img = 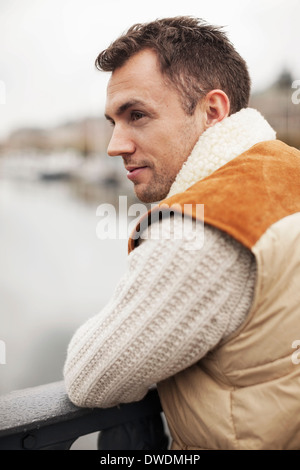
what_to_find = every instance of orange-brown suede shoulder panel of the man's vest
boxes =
[128,140,300,252]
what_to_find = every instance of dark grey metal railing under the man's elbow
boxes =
[0,382,169,450]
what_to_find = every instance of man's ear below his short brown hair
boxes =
[203,90,230,129]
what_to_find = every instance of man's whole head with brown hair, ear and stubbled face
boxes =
[96,17,250,202]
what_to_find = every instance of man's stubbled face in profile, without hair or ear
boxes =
[105,49,205,202]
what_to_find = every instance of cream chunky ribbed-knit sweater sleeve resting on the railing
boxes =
[64,218,256,408]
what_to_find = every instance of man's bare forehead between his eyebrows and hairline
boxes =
[106,49,168,114]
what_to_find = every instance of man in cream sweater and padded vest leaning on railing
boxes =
[64,17,300,449]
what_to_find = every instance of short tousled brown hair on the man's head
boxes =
[95,16,250,115]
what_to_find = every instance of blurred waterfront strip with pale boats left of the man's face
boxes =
[0,117,136,205]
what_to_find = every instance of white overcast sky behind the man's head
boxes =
[0,0,300,138]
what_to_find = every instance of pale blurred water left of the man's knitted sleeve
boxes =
[0,179,127,394]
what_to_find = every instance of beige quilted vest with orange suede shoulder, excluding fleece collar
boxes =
[129,141,300,449]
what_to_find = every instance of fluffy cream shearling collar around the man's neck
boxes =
[167,108,276,197]
